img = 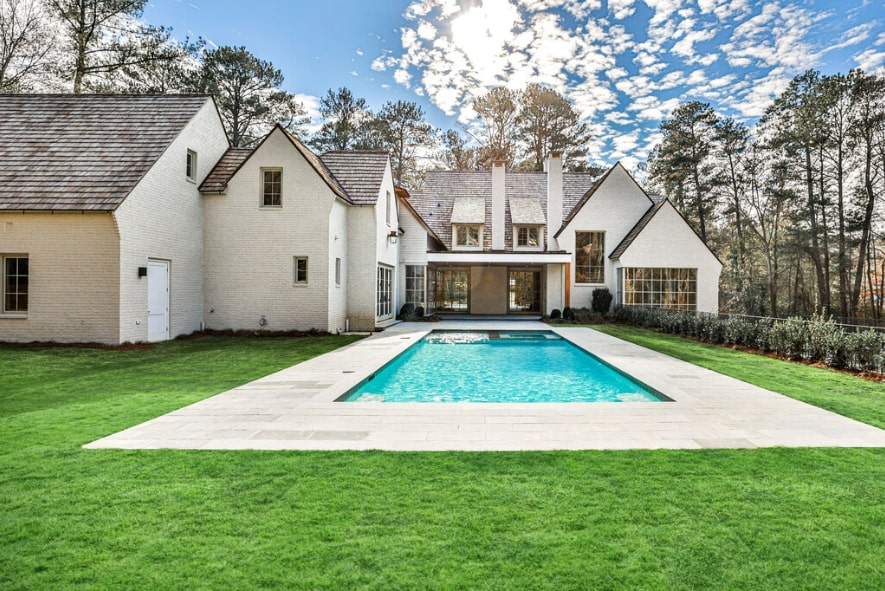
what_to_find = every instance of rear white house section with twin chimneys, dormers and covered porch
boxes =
[400,155,722,315]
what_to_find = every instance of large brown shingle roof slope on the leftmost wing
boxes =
[0,94,212,211]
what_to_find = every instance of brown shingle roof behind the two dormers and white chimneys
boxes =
[409,170,596,250]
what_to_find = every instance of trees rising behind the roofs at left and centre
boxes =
[0,0,590,186]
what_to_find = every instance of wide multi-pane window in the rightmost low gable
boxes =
[619,267,698,310]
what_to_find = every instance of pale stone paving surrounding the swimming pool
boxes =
[85,321,885,451]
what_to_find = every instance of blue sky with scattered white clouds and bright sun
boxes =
[144,0,885,166]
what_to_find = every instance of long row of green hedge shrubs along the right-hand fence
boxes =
[614,306,885,373]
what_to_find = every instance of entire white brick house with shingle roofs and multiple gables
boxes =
[0,95,721,344]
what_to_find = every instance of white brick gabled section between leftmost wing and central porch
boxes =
[201,126,399,332]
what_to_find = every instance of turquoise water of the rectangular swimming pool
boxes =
[343,331,661,402]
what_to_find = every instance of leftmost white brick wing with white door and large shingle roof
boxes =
[0,95,228,343]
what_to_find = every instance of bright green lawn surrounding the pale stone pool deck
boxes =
[0,327,885,591]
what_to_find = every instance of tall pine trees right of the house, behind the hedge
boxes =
[648,70,885,319]
